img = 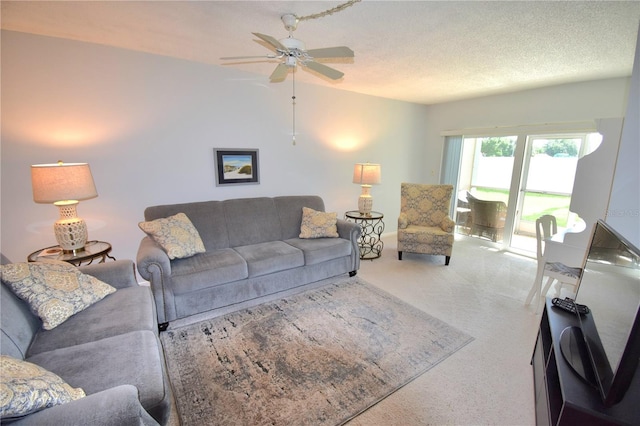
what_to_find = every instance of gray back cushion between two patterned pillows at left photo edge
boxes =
[0,283,41,359]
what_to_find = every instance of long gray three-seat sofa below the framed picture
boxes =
[136,196,361,326]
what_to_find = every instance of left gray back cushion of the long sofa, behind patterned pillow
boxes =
[144,201,230,251]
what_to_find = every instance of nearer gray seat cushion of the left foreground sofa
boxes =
[28,330,169,411]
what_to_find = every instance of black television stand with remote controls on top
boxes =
[531,299,640,426]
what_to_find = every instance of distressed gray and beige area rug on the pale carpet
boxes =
[161,277,473,426]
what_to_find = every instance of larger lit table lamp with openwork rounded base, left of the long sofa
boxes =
[31,161,98,253]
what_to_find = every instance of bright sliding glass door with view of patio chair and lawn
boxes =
[445,128,601,252]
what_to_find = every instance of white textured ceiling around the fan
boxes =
[1,0,640,104]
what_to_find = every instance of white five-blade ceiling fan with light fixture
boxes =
[220,14,354,83]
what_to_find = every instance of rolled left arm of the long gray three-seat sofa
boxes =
[136,237,177,324]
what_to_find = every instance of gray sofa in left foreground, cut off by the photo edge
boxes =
[0,260,173,426]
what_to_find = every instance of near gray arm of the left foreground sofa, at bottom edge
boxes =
[12,385,158,426]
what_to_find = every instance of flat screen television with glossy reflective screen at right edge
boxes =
[576,220,640,407]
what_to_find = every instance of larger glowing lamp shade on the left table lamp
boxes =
[31,163,98,203]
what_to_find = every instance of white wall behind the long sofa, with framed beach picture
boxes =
[0,31,430,261]
